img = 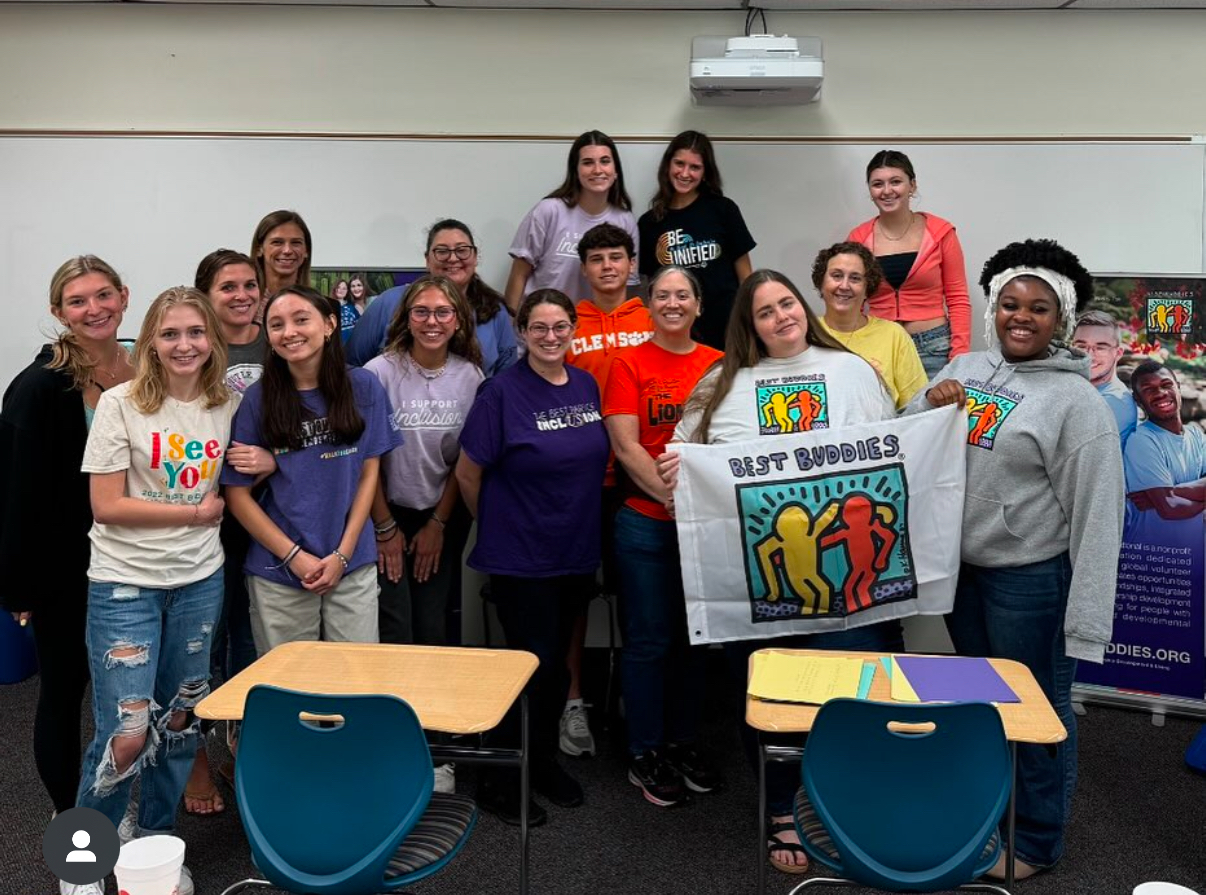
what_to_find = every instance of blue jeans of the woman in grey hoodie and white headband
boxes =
[947,554,1076,867]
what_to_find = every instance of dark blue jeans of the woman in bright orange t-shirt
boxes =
[615,507,706,755]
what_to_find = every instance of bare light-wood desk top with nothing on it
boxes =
[197,640,538,733]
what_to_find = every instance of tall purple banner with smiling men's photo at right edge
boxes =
[1073,275,1206,700]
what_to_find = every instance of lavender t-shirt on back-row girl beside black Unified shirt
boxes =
[508,199,640,302]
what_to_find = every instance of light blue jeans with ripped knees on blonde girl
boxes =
[76,569,222,835]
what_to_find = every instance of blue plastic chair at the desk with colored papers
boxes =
[792,700,1013,893]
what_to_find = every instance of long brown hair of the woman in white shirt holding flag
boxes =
[685,269,854,443]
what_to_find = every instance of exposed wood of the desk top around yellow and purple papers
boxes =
[745,649,1067,743]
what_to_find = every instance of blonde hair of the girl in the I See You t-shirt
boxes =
[130,286,230,414]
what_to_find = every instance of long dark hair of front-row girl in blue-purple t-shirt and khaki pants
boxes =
[259,286,364,451]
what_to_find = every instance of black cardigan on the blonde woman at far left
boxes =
[0,345,92,613]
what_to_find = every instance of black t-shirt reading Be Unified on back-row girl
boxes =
[637,193,757,351]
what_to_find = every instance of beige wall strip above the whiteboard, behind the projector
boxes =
[0,4,1206,138]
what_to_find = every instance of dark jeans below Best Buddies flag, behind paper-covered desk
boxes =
[725,619,905,818]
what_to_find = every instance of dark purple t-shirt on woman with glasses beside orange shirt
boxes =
[461,359,610,578]
